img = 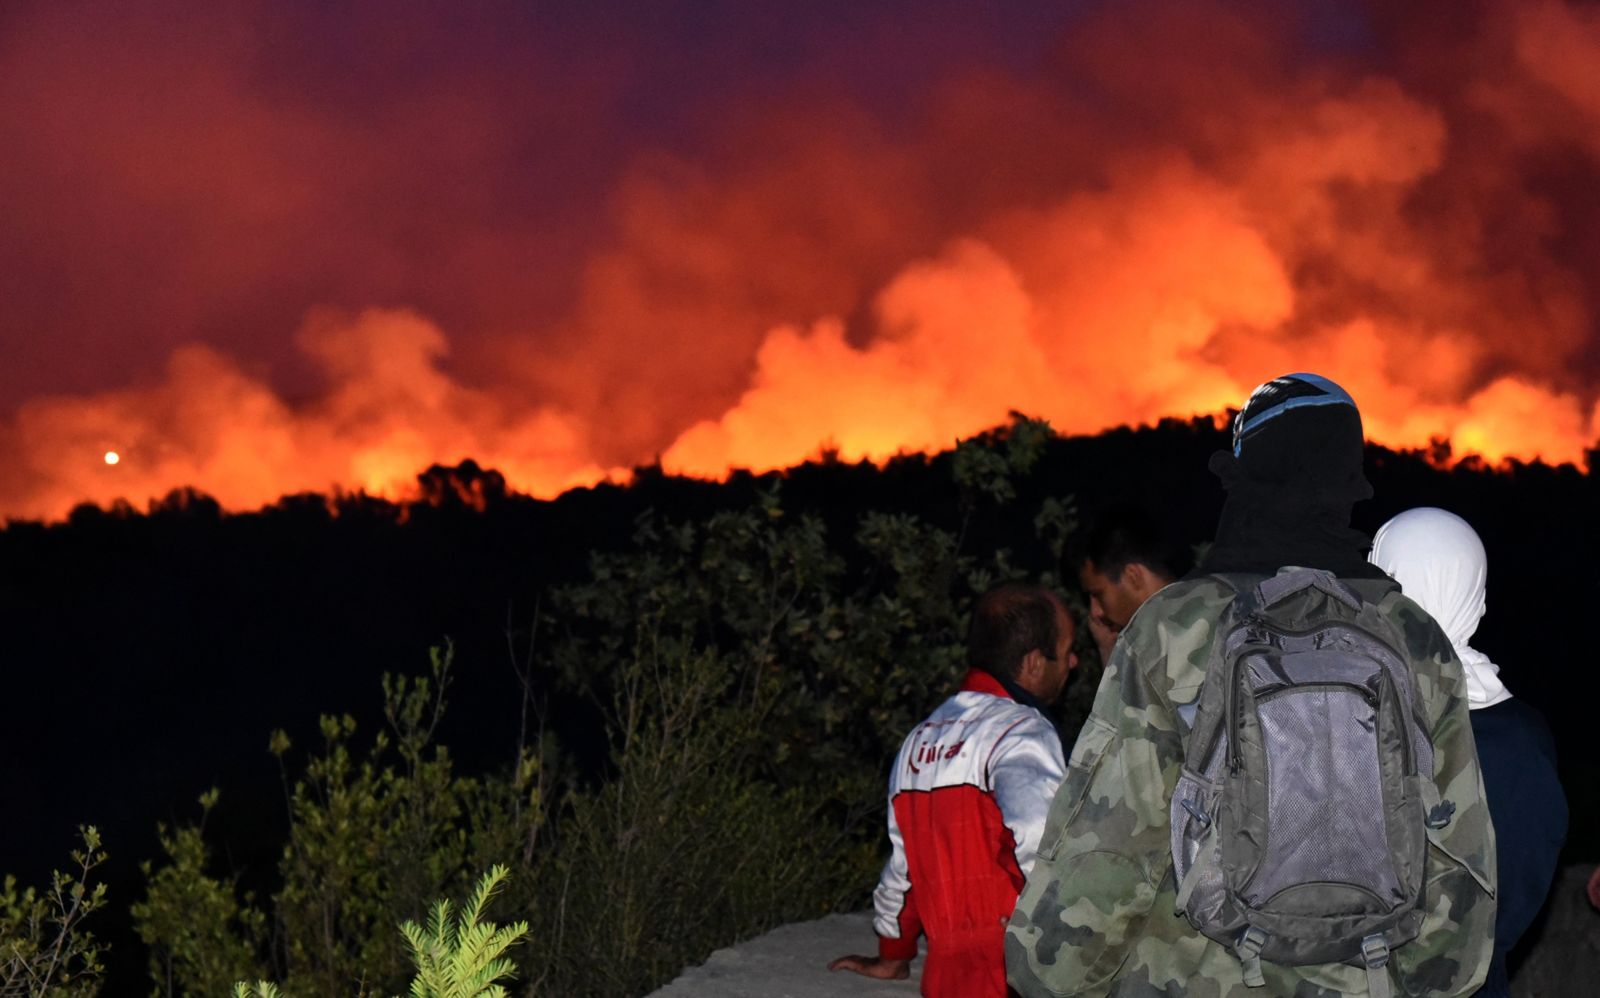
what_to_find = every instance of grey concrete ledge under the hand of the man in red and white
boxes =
[650,912,922,998]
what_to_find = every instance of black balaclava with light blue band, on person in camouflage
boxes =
[1195,374,1382,579]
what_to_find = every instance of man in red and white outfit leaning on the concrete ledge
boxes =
[829,584,1077,998]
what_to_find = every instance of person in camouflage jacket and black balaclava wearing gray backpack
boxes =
[1006,374,1494,998]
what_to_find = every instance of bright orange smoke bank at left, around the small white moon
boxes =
[3,310,606,518]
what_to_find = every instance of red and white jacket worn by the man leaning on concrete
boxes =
[872,669,1066,998]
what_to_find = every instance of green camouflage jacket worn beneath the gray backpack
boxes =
[1006,579,1494,998]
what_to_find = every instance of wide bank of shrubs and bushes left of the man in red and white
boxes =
[124,422,1072,995]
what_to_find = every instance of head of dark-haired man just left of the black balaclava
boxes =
[1078,505,1182,662]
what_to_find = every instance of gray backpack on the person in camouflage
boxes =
[1171,569,1453,998]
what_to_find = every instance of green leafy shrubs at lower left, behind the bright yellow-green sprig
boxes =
[133,648,526,995]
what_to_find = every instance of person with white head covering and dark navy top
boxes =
[1371,507,1566,998]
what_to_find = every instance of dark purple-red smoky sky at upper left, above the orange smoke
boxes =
[0,0,1066,409]
